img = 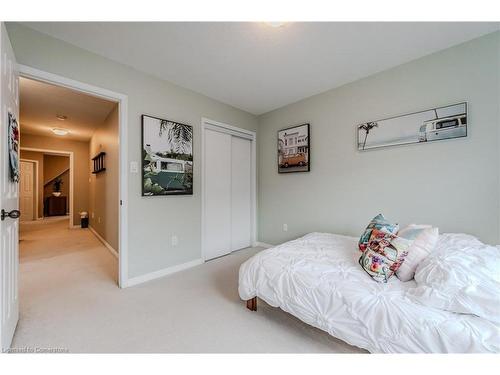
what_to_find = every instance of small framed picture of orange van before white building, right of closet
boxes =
[278,124,311,173]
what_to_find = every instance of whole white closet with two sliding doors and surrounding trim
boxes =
[202,119,256,260]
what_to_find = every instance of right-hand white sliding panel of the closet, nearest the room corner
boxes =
[231,136,252,251]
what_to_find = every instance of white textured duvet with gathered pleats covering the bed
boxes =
[239,233,500,353]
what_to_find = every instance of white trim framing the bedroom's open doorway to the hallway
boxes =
[18,64,128,288]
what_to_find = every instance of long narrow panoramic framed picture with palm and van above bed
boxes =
[357,102,467,151]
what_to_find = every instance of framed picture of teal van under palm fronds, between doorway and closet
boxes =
[142,115,193,196]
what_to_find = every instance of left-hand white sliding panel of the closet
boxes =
[204,129,232,259]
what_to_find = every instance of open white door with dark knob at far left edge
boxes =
[0,23,19,351]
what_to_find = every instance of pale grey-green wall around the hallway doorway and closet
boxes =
[7,23,258,277]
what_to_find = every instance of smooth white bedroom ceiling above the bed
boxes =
[20,22,499,115]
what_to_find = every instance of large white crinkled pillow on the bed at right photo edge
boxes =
[407,234,500,323]
